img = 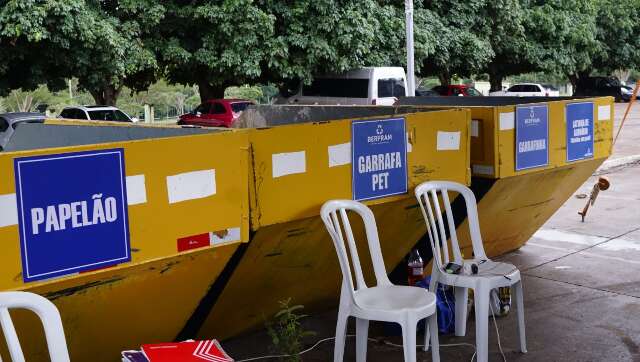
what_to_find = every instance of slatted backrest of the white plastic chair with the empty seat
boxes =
[320,200,391,293]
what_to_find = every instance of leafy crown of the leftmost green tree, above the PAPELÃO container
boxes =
[0,0,158,105]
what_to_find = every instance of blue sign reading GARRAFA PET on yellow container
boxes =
[351,118,407,200]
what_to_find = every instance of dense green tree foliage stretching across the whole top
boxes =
[0,0,640,104]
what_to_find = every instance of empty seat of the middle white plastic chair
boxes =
[355,285,436,312]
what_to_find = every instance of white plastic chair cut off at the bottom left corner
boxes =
[0,292,69,362]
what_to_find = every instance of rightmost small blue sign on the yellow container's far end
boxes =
[566,102,593,162]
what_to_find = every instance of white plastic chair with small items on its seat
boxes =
[415,181,527,362]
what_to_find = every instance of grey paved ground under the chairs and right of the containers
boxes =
[224,104,640,362]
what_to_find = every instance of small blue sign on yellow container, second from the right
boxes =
[516,105,549,171]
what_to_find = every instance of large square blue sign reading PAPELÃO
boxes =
[14,148,131,282]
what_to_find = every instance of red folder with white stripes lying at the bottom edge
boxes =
[142,339,233,362]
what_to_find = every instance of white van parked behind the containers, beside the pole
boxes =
[276,67,407,105]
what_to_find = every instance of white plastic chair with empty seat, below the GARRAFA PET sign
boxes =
[320,200,440,362]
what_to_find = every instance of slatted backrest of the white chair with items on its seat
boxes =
[415,181,487,269]
